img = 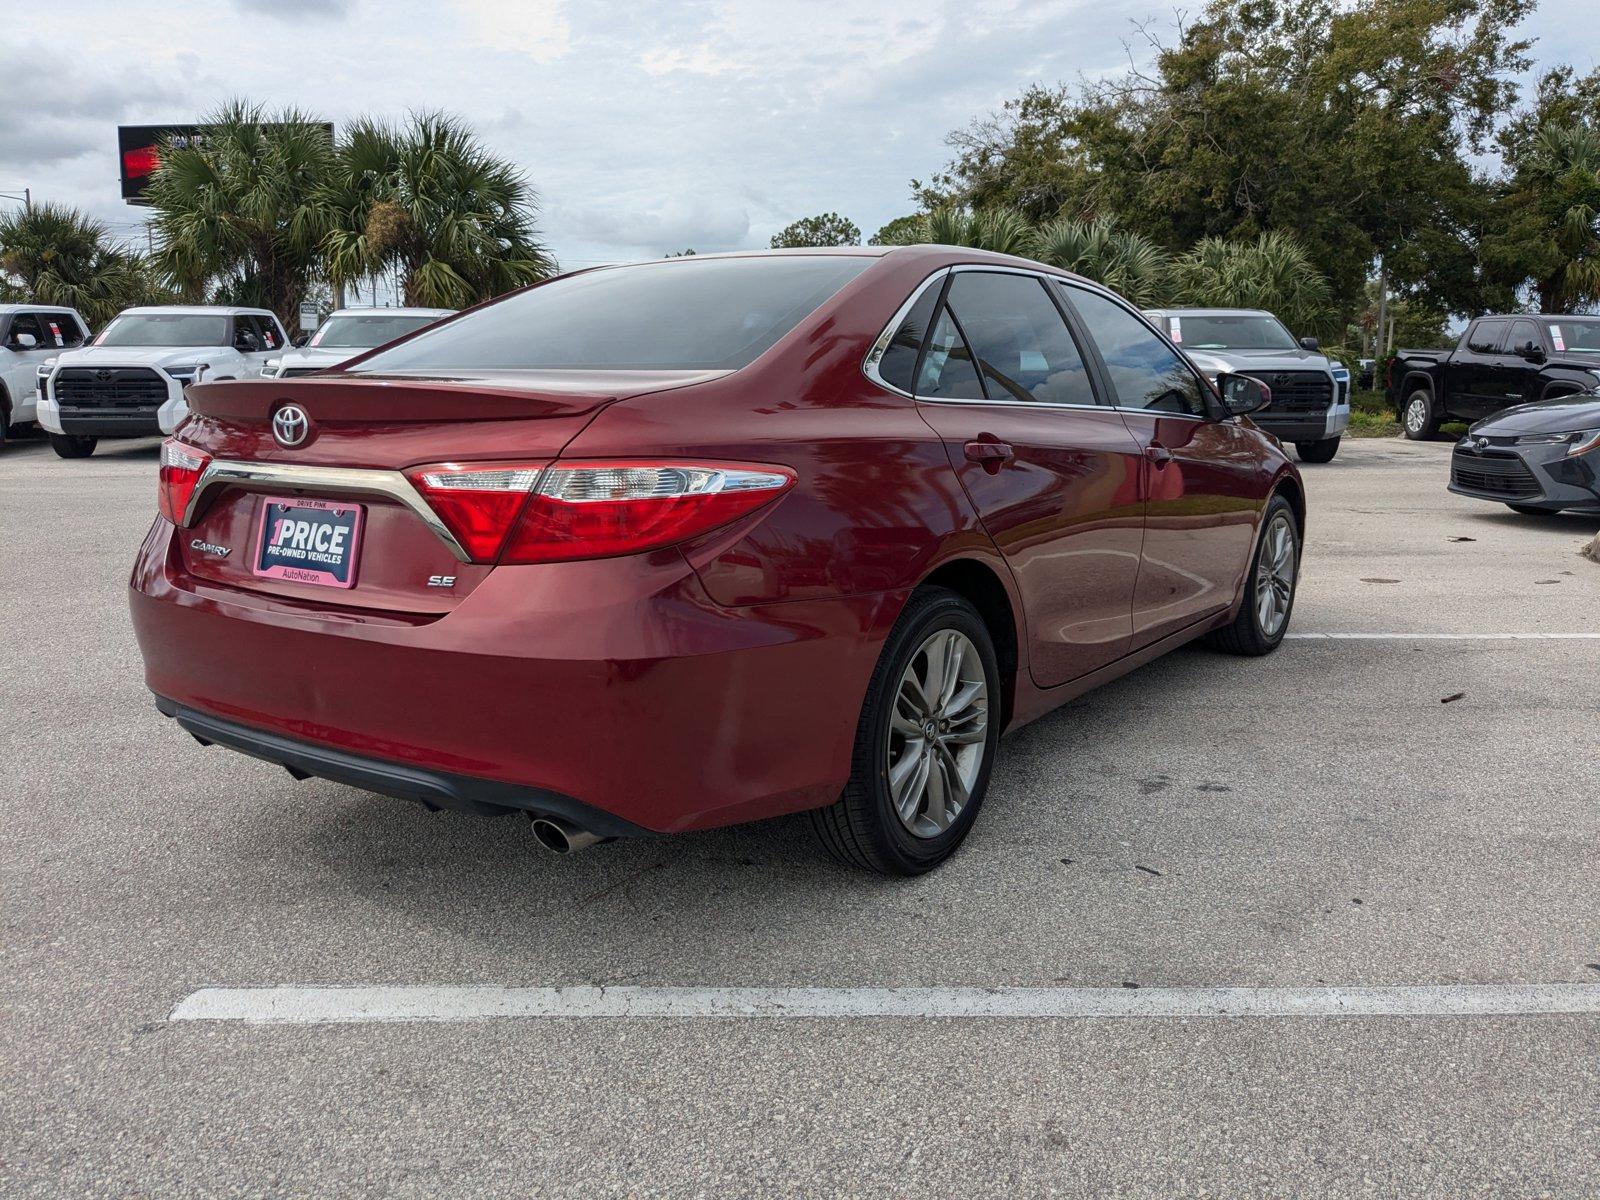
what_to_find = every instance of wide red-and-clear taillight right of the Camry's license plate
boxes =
[406,459,795,563]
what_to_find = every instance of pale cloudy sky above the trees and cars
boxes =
[0,0,1600,267]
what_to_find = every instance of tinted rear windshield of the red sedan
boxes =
[349,254,872,373]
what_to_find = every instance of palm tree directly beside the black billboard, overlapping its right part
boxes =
[146,101,333,325]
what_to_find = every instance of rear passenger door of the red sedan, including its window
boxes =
[915,269,1144,686]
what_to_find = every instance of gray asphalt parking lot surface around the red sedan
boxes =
[0,440,1600,1195]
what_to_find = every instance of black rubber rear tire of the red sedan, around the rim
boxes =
[811,587,1002,875]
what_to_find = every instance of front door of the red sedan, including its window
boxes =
[1058,283,1261,650]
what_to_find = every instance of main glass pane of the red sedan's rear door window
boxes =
[946,270,1094,405]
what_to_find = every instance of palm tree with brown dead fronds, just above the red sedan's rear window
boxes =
[318,114,555,307]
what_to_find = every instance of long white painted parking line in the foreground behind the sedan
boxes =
[170,984,1600,1026]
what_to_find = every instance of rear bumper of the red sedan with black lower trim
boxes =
[130,520,904,832]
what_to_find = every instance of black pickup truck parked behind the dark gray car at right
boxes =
[1386,315,1600,440]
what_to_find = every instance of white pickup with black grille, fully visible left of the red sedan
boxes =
[38,306,288,458]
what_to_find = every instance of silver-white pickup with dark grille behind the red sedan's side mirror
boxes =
[1144,309,1350,462]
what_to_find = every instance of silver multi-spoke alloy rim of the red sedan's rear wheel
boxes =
[885,629,989,838]
